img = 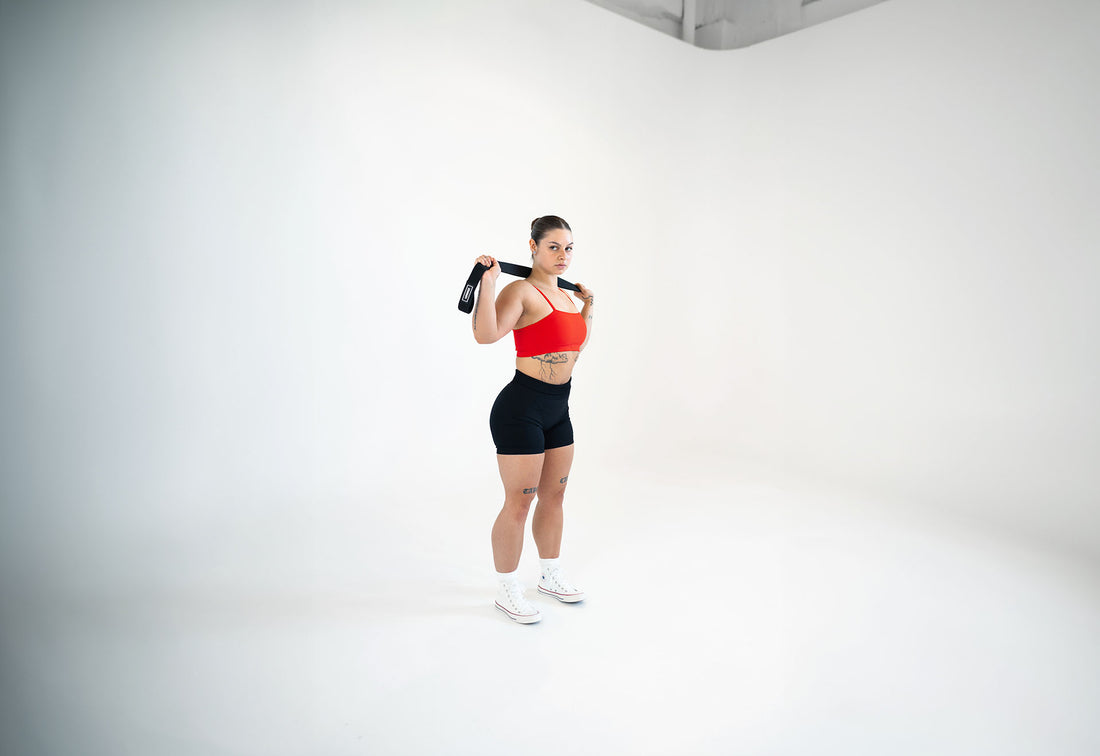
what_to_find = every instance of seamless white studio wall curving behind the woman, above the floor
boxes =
[3,1,1100,598]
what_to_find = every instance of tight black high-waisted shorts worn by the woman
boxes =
[488,370,573,454]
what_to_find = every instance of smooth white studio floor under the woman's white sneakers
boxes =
[0,476,1100,756]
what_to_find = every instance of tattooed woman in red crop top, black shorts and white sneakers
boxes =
[473,216,595,624]
